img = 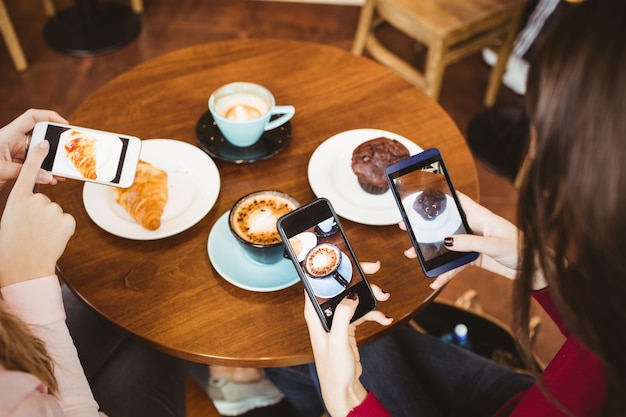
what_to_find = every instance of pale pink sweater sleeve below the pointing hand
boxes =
[1,275,99,417]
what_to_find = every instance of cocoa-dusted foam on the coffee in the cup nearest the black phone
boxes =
[231,194,296,245]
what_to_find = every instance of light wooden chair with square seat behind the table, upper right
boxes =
[352,0,528,107]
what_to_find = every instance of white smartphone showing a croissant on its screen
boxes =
[29,122,141,188]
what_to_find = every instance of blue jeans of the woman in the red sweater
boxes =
[266,326,533,417]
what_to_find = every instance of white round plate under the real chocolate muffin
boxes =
[308,129,423,226]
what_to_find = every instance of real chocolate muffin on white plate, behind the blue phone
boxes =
[352,137,410,194]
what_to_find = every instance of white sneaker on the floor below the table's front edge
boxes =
[207,376,285,416]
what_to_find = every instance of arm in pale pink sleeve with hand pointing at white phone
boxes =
[0,141,98,416]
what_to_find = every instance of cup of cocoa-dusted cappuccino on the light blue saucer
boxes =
[228,190,300,264]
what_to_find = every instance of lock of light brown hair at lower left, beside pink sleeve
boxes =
[0,300,58,395]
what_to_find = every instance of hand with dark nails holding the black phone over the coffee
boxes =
[304,262,393,416]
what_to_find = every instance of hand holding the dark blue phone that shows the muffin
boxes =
[401,193,519,289]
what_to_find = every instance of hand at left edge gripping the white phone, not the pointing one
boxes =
[0,109,68,189]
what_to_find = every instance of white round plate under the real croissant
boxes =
[83,139,220,240]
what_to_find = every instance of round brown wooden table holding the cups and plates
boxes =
[43,39,478,367]
